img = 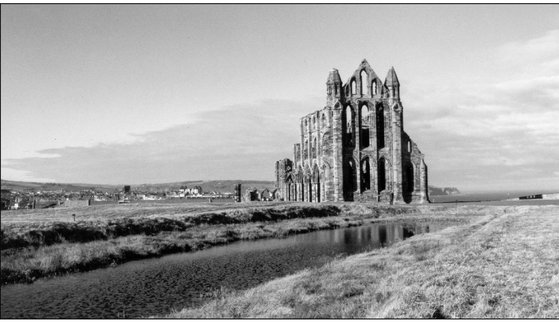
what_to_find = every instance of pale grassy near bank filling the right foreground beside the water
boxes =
[165,206,559,318]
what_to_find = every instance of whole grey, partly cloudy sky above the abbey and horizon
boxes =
[1,4,559,191]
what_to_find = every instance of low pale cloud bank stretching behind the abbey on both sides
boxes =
[2,30,559,190]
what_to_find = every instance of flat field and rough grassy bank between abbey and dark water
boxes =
[0,203,475,285]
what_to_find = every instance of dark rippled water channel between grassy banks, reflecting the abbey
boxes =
[1,223,450,318]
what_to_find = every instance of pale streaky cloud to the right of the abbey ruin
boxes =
[405,30,559,189]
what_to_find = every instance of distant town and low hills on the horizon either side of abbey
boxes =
[1,180,460,210]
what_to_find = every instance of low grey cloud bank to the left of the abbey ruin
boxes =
[2,100,313,183]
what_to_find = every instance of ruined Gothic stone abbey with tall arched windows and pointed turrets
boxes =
[276,60,429,204]
